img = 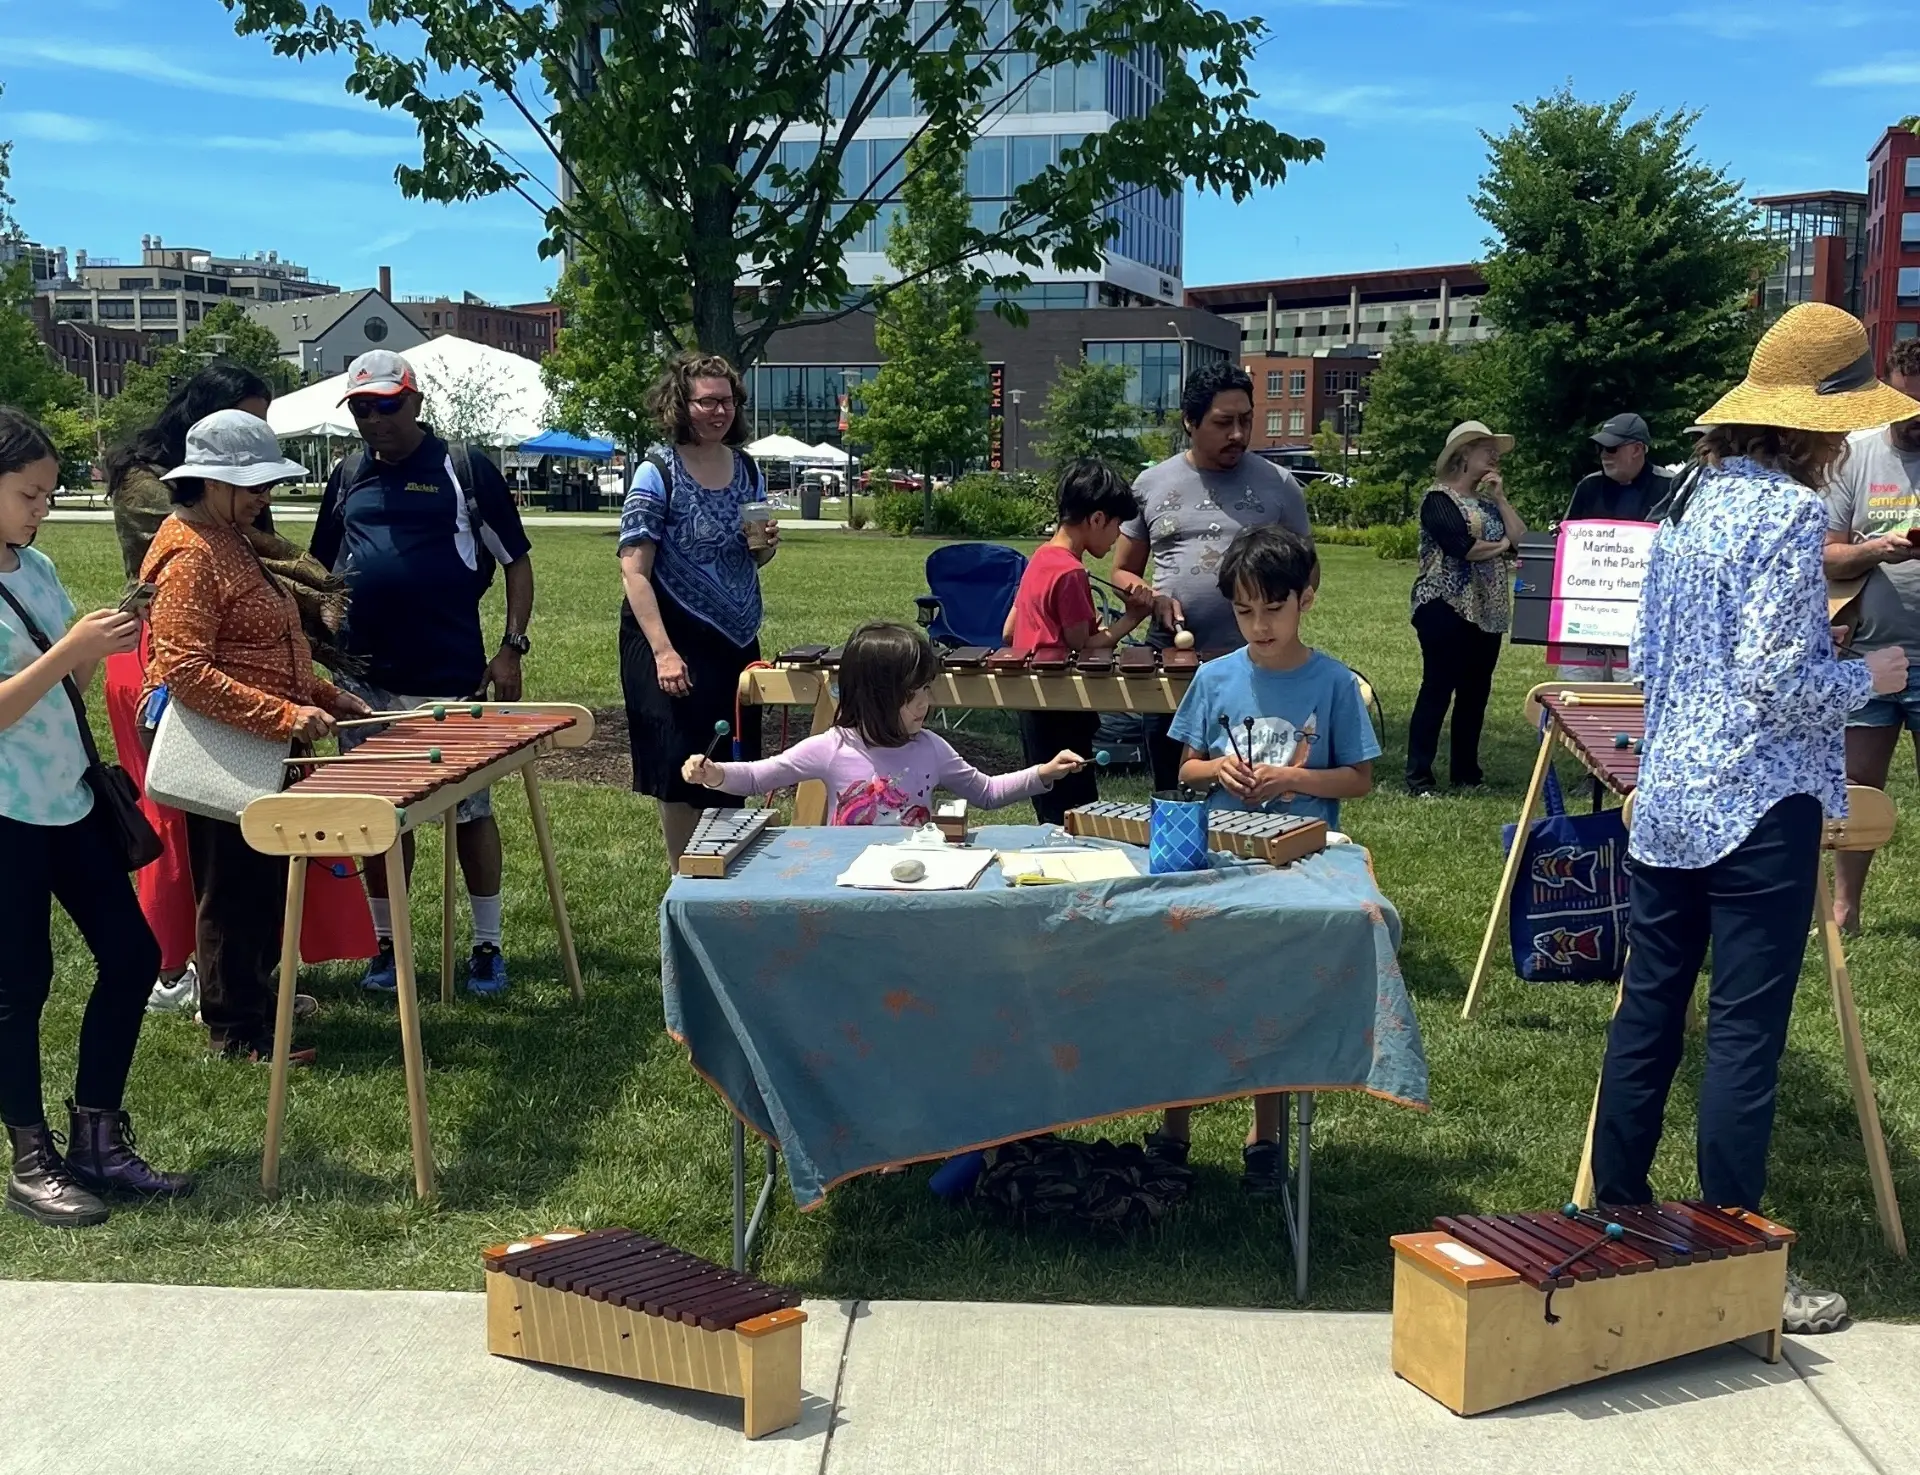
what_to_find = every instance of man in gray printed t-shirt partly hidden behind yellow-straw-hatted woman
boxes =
[1826,338,1920,931]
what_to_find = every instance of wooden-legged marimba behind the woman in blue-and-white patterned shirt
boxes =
[1461,682,1907,1258]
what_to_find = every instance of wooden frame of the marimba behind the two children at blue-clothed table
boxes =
[739,664,1198,824]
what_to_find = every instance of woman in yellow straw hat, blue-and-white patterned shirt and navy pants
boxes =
[1594,303,1920,1333]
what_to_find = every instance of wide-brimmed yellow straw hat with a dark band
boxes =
[1699,302,1920,432]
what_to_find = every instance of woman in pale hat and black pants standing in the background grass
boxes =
[1407,421,1526,795]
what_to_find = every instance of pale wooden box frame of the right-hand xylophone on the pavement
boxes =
[1392,1214,1793,1415]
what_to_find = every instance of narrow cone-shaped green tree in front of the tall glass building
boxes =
[847,136,987,505]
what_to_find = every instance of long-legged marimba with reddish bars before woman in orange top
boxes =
[240,701,593,1198]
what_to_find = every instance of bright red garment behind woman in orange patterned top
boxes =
[106,632,376,972]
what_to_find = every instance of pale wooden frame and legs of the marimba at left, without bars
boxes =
[240,701,593,1198]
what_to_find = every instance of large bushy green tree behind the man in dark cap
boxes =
[1475,90,1776,517]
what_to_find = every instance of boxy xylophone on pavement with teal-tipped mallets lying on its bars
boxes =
[1392,1202,1793,1414]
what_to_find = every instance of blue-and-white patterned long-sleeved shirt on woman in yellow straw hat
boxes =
[1630,457,1870,870]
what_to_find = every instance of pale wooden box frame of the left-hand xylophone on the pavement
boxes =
[482,1229,806,1439]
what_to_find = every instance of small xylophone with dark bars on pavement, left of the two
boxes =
[480,1229,806,1439]
